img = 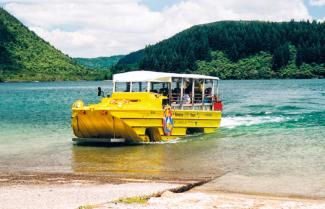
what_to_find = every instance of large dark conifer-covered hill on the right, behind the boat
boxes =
[114,21,325,79]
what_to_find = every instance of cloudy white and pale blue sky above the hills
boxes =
[0,0,325,57]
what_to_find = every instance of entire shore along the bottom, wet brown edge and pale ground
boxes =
[0,173,325,209]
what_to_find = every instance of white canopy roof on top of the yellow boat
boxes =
[113,70,219,82]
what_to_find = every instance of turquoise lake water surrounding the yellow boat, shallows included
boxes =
[0,80,325,197]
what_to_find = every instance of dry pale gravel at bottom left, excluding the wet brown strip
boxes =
[0,182,182,209]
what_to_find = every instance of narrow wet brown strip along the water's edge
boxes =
[0,171,325,201]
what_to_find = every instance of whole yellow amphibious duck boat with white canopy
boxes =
[72,71,222,143]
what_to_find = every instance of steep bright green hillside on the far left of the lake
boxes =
[0,8,104,81]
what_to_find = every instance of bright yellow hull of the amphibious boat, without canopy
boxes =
[72,92,221,143]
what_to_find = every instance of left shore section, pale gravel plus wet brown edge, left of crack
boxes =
[0,173,184,209]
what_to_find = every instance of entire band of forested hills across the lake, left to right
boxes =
[0,5,325,81]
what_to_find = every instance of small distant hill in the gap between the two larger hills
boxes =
[73,55,124,69]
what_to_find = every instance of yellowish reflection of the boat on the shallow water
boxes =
[72,136,224,179]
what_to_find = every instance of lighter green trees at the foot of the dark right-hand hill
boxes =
[195,45,325,79]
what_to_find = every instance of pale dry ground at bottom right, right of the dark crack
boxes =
[102,192,325,209]
